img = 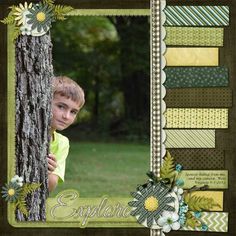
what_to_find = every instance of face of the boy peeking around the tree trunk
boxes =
[51,94,80,130]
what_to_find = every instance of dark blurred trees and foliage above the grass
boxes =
[51,16,150,143]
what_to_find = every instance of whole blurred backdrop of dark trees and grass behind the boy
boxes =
[51,16,150,197]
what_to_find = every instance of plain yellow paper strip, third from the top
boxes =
[164,47,219,66]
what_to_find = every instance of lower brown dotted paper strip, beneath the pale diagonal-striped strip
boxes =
[168,148,225,170]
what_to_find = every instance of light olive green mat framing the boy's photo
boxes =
[8,6,157,230]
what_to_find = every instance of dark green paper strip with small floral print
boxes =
[164,66,228,88]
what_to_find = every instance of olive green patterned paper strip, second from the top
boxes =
[165,27,224,47]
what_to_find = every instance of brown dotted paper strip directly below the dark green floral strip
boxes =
[164,88,232,108]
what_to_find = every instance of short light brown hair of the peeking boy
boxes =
[53,76,85,108]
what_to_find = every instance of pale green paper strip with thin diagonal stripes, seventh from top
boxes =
[164,129,215,148]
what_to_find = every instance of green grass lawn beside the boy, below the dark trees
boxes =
[50,142,150,197]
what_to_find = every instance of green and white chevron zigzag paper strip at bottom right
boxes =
[180,212,229,232]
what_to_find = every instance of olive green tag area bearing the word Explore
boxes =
[46,189,138,227]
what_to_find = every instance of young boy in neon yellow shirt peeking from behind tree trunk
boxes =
[48,76,85,192]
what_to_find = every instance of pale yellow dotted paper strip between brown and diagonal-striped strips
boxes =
[165,108,228,129]
